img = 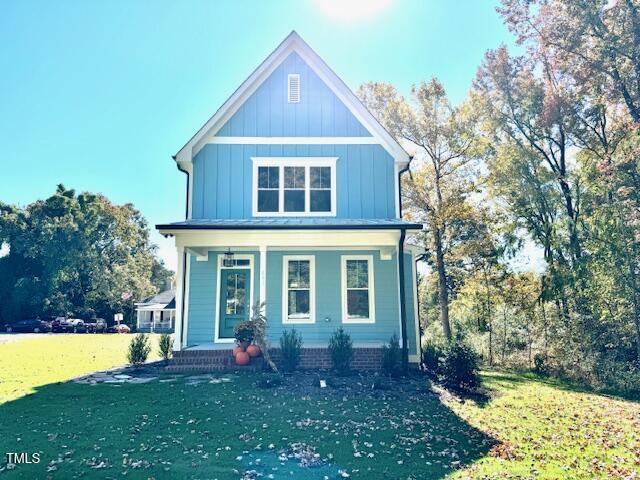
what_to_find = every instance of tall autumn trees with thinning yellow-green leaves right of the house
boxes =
[359,0,640,398]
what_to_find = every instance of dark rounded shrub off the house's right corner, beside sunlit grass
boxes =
[438,336,479,390]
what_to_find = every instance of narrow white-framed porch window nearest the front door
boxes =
[282,255,316,324]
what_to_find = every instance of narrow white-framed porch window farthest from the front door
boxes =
[341,255,376,323]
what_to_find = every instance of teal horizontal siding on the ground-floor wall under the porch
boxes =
[187,250,416,354]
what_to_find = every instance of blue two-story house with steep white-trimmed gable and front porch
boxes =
[157,32,422,368]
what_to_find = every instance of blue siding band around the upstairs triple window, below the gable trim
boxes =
[192,144,396,219]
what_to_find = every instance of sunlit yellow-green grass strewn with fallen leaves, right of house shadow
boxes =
[448,372,640,479]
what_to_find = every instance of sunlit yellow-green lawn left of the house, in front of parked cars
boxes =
[0,334,158,402]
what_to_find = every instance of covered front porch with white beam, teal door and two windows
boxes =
[161,224,421,369]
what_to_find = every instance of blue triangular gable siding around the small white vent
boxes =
[216,52,371,137]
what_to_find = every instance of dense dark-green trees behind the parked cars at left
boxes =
[0,185,172,323]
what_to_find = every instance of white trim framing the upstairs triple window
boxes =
[251,157,338,217]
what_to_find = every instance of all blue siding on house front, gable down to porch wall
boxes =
[176,34,418,355]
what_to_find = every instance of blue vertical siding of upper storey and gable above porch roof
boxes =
[191,48,397,219]
